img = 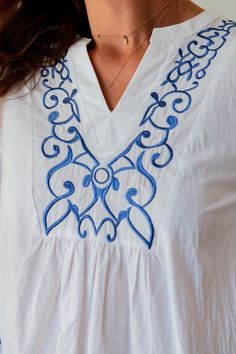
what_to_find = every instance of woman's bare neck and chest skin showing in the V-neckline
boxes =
[85,0,204,111]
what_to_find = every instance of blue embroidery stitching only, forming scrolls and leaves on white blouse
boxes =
[41,20,236,249]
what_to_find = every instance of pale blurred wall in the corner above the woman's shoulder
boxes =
[193,0,236,20]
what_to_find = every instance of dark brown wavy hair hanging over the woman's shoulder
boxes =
[0,0,91,97]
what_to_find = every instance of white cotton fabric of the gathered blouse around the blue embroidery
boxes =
[0,9,236,354]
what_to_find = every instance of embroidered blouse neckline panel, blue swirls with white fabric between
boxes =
[41,20,236,249]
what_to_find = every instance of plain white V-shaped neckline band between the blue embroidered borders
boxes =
[66,10,218,162]
